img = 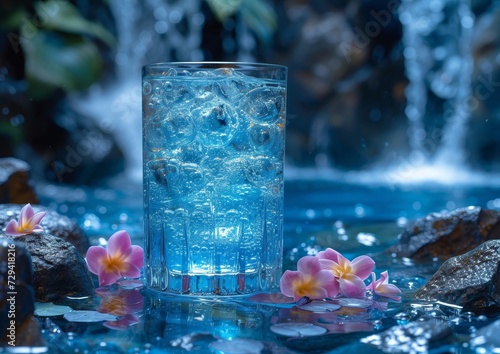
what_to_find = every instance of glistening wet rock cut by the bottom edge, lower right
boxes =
[361,319,453,353]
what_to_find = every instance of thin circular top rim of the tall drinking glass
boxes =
[142,61,288,70]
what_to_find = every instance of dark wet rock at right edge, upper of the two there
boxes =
[389,207,500,260]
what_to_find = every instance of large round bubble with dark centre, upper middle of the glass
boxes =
[193,101,238,146]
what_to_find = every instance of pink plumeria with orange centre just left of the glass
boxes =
[86,231,144,286]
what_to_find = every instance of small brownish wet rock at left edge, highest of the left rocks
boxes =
[0,157,38,204]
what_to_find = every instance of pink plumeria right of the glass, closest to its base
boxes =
[280,256,339,301]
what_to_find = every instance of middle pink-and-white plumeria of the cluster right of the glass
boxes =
[316,248,375,298]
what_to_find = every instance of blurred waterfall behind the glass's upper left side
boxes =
[70,0,204,182]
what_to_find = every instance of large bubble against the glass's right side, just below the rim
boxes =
[241,87,285,123]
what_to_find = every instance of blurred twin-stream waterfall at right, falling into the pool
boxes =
[399,0,474,172]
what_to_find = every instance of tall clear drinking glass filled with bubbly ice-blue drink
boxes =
[142,62,287,296]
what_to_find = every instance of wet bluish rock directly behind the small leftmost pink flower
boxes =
[0,204,90,254]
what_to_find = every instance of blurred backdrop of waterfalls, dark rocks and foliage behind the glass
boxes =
[0,0,500,185]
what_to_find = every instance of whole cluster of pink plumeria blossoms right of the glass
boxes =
[280,248,401,304]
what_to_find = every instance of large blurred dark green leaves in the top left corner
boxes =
[3,0,115,99]
